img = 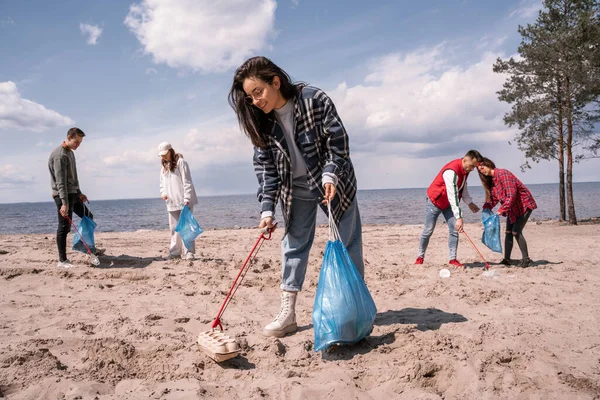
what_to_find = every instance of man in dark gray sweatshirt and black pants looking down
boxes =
[48,128,99,268]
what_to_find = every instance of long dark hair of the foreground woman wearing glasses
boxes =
[228,56,306,148]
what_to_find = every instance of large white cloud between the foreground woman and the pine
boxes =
[331,45,507,155]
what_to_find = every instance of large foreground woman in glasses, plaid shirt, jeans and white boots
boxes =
[229,57,364,337]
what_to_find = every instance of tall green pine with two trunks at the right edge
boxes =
[494,0,600,224]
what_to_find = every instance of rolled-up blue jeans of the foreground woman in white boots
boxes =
[281,191,365,292]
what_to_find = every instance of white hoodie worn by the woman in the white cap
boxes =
[160,157,198,211]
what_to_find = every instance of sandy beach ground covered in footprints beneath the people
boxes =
[0,221,600,400]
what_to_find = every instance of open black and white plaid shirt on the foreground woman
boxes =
[253,86,356,231]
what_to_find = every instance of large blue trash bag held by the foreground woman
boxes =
[312,240,377,351]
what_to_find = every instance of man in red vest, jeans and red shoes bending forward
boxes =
[415,150,483,267]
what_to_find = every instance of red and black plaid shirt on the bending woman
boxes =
[484,168,537,223]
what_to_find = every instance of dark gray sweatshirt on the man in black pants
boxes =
[48,144,81,205]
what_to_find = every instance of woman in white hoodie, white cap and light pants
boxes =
[158,142,198,260]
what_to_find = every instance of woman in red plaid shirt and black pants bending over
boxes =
[477,157,537,268]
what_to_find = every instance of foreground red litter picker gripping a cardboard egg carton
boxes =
[198,224,277,362]
